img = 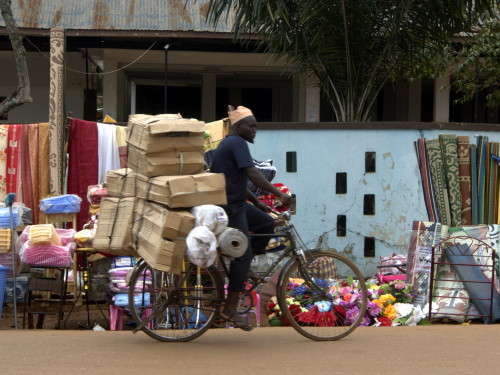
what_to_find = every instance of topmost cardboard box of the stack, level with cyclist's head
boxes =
[127,115,205,154]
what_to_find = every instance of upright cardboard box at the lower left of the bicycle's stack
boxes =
[92,198,137,256]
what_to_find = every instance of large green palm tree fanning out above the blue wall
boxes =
[208,0,495,122]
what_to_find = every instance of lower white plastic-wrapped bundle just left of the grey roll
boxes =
[186,225,217,268]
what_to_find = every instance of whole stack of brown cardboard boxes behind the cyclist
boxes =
[93,115,226,273]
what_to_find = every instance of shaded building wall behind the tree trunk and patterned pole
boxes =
[0,52,85,123]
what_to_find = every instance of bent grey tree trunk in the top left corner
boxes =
[0,0,32,116]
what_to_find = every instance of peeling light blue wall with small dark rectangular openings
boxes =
[250,129,500,276]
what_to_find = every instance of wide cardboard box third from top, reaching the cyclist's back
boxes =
[136,172,227,208]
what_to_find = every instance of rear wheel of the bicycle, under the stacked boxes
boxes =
[129,262,224,341]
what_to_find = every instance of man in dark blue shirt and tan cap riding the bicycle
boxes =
[210,106,292,331]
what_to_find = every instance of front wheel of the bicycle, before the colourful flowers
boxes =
[277,250,368,341]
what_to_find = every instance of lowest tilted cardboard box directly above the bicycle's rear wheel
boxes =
[137,220,186,274]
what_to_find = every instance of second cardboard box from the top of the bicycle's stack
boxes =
[127,146,205,177]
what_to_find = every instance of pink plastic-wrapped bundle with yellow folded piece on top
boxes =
[18,224,76,268]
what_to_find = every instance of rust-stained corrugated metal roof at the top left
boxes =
[0,0,232,32]
